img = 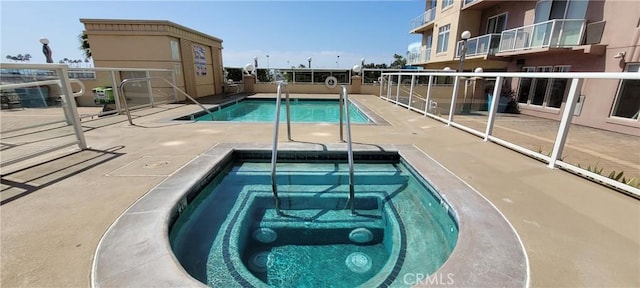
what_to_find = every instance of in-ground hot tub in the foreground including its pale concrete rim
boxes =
[91,142,529,287]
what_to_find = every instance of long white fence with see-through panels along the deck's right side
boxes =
[380,72,640,198]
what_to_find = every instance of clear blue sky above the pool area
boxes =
[0,0,425,68]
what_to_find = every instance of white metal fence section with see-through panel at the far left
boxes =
[0,63,87,166]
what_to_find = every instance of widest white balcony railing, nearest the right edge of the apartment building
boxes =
[498,19,586,52]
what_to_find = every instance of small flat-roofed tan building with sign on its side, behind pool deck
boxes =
[80,19,223,97]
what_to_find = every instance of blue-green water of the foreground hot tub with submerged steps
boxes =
[170,161,458,287]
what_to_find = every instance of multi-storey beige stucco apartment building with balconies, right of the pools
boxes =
[407,0,640,135]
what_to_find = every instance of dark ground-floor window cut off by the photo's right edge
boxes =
[611,63,640,120]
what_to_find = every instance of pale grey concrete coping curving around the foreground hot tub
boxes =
[91,142,530,287]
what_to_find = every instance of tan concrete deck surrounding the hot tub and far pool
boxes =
[0,95,640,287]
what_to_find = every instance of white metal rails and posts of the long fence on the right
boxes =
[380,72,640,198]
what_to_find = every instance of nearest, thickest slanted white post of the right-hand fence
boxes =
[547,78,583,168]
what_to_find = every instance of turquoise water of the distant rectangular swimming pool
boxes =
[195,99,371,123]
